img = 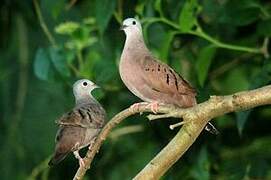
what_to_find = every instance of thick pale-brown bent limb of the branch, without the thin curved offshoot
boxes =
[134,85,271,180]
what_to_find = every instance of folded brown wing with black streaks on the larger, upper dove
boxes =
[140,55,196,96]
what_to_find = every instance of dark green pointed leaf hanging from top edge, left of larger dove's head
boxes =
[95,0,116,33]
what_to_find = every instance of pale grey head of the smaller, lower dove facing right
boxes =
[73,79,99,99]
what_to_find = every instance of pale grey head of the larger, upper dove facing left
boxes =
[121,18,142,36]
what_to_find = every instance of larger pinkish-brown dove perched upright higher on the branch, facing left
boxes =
[119,18,218,134]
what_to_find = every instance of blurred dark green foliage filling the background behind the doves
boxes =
[0,0,271,180]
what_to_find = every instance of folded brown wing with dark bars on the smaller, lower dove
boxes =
[57,103,105,129]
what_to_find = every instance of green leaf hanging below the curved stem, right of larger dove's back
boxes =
[196,45,216,86]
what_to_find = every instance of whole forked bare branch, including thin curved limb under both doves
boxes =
[74,85,271,180]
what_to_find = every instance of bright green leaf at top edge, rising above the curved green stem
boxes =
[179,0,199,32]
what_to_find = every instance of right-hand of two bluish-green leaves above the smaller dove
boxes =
[49,47,70,77]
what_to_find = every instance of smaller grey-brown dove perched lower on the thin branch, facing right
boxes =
[48,79,106,166]
